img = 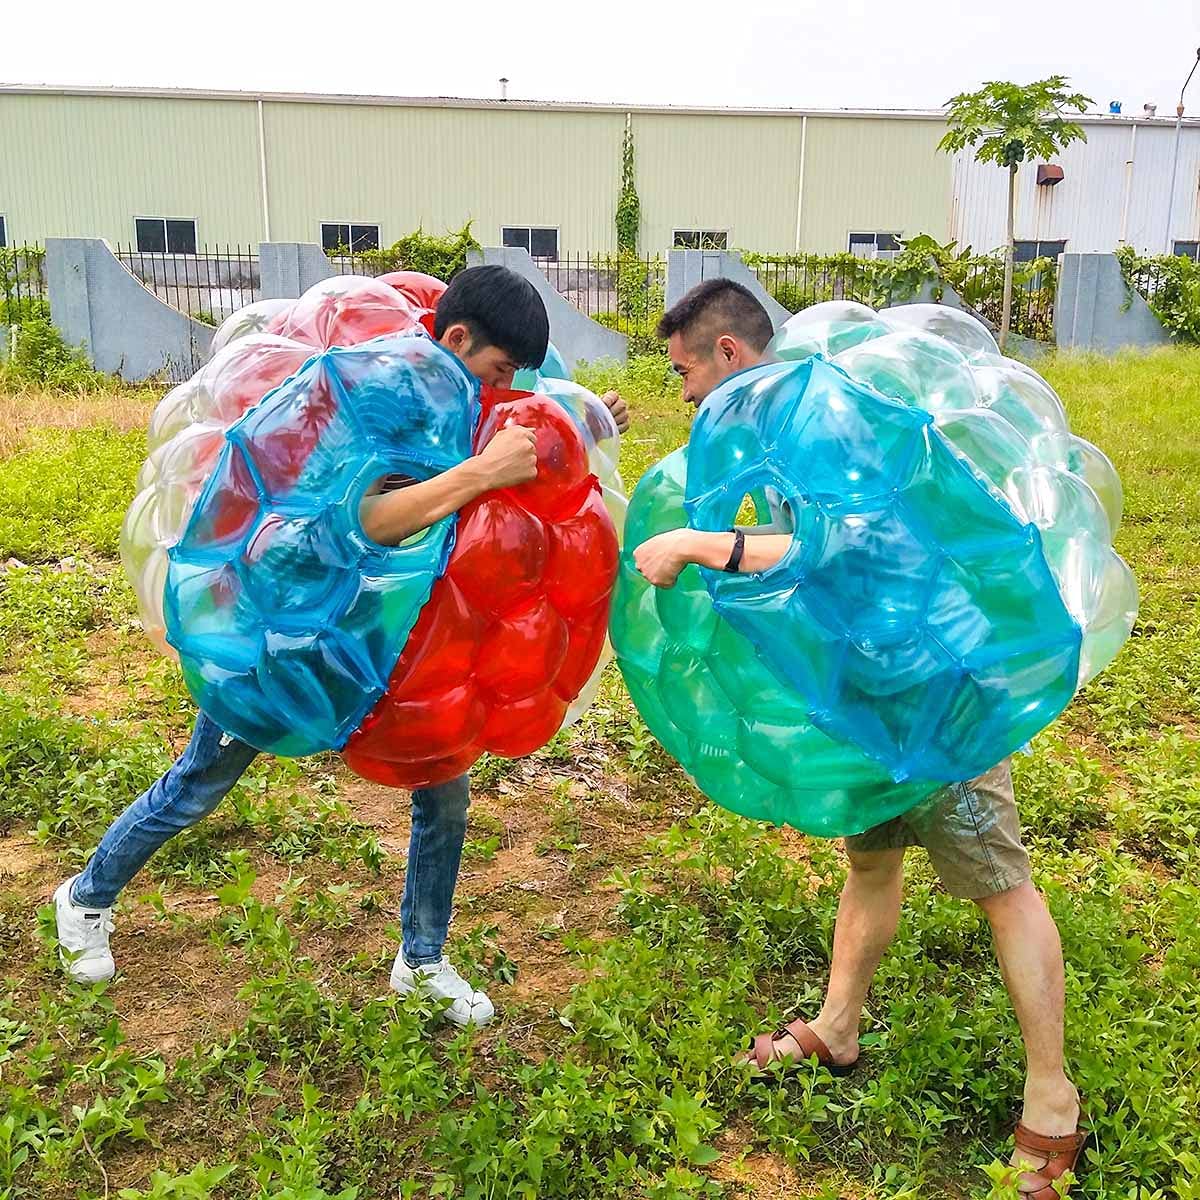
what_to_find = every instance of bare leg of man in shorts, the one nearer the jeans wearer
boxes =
[775,850,904,1063]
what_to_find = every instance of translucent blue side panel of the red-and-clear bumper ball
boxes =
[166,335,478,755]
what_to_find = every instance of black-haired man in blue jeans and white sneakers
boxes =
[54,266,629,1025]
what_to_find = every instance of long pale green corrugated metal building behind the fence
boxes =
[0,88,952,254]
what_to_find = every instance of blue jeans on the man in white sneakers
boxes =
[71,713,470,967]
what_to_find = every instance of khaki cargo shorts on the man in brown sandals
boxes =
[846,758,1030,900]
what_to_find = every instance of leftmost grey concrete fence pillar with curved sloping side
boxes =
[46,238,215,383]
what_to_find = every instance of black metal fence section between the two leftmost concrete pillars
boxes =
[115,245,262,325]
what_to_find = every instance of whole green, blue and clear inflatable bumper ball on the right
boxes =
[611,301,1138,836]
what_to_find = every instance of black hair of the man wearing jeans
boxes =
[433,265,550,367]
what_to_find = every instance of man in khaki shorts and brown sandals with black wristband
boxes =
[634,280,1085,1200]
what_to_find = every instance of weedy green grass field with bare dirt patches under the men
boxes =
[0,350,1200,1200]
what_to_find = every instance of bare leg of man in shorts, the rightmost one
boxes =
[976,882,1079,1166]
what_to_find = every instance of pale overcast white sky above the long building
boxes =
[7,0,1200,115]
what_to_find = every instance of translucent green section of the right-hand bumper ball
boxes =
[610,448,937,838]
